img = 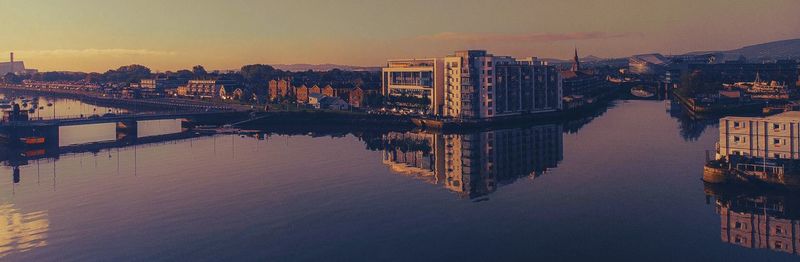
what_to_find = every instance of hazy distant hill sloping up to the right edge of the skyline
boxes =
[688,39,800,60]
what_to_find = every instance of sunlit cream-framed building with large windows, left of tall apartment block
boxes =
[381,58,444,115]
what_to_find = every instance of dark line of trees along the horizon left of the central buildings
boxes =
[3,64,381,88]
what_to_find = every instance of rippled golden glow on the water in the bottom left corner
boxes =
[0,204,50,258]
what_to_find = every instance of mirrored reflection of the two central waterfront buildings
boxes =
[381,125,563,199]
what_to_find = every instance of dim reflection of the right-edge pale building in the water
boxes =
[705,184,800,255]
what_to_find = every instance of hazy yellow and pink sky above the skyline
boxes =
[0,0,800,72]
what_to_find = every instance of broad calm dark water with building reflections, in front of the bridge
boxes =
[0,101,800,261]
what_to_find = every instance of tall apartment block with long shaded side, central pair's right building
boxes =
[443,50,563,119]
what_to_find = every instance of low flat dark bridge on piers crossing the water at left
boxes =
[0,111,247,145]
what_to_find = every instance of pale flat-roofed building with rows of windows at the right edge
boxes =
[717,111,800,159]
